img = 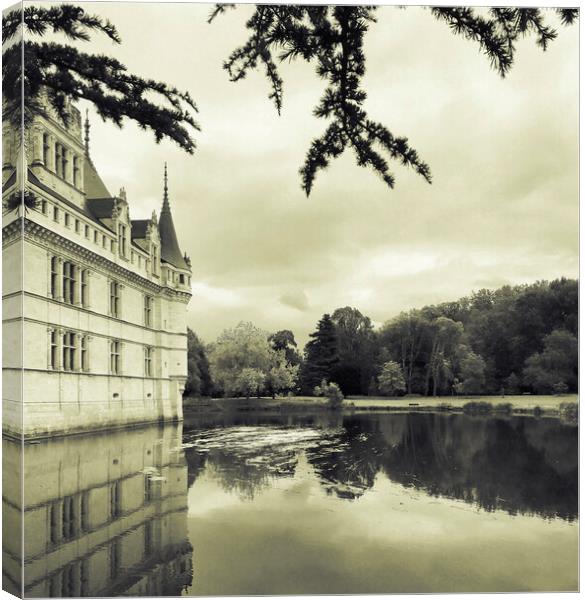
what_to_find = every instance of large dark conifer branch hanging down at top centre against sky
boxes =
[217,5,431,195]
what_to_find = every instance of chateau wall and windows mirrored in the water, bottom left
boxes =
[2,425,193,597]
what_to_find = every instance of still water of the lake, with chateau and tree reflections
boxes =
[3,413,578,597]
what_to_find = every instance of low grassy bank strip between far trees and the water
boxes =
[183,394,579,418]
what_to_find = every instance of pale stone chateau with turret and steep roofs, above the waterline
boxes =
[2,97,191,438]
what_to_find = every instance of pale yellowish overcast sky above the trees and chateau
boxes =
[72,3,578,343]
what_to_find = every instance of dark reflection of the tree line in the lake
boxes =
[184,413,578,521]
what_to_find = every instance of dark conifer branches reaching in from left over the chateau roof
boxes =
[2,5,199,153]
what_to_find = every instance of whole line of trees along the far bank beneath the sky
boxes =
[186,278,578,397]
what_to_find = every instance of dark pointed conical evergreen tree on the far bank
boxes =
[301,314,339,394]
